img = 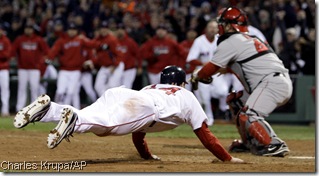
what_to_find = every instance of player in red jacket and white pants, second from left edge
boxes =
[12,24,49,111]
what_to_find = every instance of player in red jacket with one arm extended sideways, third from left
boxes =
[48,23,101,104]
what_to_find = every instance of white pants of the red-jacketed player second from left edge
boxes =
[16,69,40,111]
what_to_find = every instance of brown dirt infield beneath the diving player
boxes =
[0,130,316,173]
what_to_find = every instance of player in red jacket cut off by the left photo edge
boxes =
[0,24,11,116]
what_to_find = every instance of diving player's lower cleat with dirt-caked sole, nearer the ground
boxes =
[47,108,78,149]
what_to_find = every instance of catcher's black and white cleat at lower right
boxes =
[256,142,290,157]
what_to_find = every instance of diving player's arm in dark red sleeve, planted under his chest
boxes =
[132,132,161,160]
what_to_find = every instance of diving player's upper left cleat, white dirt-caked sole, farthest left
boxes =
[13,94,51,128]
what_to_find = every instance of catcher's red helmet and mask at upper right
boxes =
[217,7,248,35]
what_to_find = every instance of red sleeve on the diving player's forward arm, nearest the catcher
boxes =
[194,122,232,161]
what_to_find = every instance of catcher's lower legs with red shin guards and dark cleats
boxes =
[230,109,289,157]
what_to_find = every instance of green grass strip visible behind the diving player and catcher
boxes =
[0,117,316,140]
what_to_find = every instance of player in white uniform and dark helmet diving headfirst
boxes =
[13,66,244,163]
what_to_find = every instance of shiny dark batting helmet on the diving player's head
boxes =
[160,65,187,85]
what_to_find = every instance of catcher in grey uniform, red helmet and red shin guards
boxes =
[191,7,292,157]
